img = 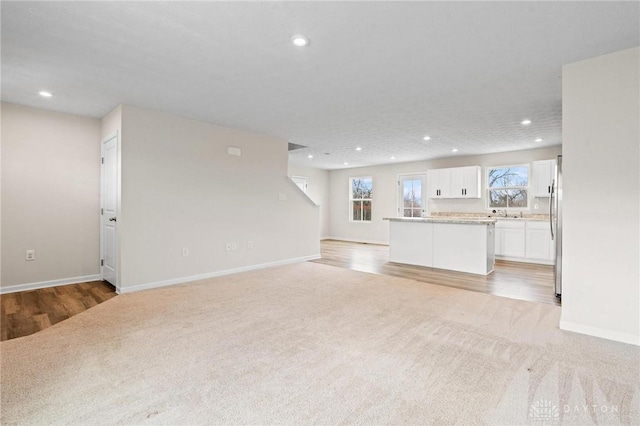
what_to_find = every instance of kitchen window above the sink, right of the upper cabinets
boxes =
[487,165,529,209]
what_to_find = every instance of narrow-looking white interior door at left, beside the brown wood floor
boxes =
[100,134,118,286]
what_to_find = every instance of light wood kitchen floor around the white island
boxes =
[313,240,560,305]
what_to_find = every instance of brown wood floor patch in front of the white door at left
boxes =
[0,281,116,340]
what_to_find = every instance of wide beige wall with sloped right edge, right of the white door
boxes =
[118,105,320,292]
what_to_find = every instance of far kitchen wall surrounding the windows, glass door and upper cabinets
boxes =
[329,146,561,244]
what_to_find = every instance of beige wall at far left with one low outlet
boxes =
[0,103,100,291]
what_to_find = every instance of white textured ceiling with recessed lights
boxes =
[1,1,640,169]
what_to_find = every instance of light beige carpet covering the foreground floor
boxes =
[0,263,640,425]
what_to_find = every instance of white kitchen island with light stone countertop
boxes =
[384,217,496,275]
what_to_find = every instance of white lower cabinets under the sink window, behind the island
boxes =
[495,220,555,264]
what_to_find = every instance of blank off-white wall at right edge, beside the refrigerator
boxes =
[560,48,640,345]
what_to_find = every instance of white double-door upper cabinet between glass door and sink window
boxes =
[427,166,481,198]
